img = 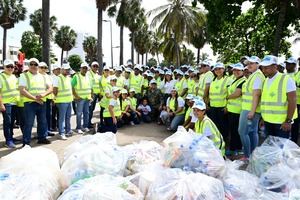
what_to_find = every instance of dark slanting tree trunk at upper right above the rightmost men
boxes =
[273,0,289,56]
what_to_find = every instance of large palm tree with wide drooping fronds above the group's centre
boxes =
[148,0,205,66]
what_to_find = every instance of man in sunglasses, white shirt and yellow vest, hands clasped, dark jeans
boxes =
[19,58,52,146]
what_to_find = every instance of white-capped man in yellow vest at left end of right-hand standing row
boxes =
[196,60,214,103]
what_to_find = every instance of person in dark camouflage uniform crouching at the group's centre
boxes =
[145,79,164,121]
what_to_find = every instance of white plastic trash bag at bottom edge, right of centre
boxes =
[146,169,225,200]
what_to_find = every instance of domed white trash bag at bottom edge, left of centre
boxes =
[58,174,144,200]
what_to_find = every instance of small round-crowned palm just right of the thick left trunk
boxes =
[55,26,77,64]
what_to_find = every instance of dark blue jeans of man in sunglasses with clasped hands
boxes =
[23,102,47,145]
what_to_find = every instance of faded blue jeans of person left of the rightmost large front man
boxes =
[239,110,261,158]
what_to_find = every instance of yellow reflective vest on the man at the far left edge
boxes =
[0,73,20,104]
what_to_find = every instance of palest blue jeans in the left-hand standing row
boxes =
[56,102,72,135]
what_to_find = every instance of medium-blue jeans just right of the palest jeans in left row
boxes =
[76,99,90,129]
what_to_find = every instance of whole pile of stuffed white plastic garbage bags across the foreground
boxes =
[0,127,300,200]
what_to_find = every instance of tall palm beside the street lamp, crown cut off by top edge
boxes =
[96,0,112,71]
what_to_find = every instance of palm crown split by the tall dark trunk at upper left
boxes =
[29,9,58,40]
